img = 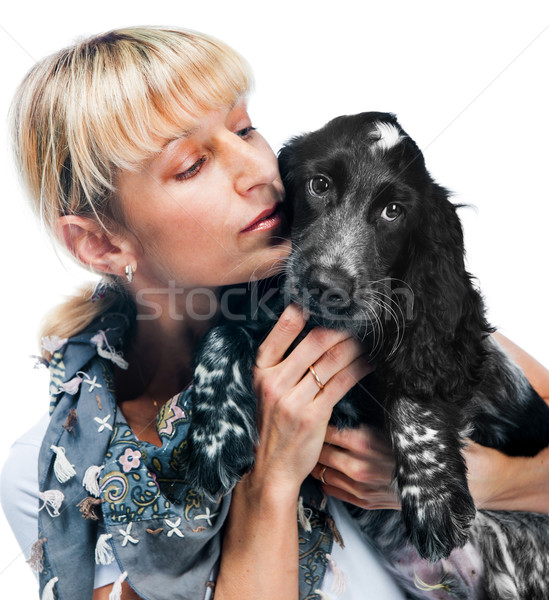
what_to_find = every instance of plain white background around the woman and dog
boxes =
[0,0,549,599]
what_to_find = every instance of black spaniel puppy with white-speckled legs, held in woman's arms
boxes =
[183,113,549,600]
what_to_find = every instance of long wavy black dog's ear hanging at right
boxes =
[395,183,493,394]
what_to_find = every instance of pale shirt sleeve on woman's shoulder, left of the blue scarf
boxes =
[0,414,49,558]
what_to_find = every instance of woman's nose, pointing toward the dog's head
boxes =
[225,136,279,195]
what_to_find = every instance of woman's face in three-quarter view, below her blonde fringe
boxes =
[117,100,290,287]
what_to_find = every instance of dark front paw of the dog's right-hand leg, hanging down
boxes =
[401,485,476,562]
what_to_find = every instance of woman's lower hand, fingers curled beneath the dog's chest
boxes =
[312,425,400,509]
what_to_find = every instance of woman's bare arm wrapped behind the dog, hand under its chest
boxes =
[304,333,549,513]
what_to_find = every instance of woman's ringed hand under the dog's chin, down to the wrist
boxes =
[253,305,373,493]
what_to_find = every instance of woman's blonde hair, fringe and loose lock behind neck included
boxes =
[10,27,252,356]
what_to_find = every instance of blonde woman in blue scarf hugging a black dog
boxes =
[3,28,549,600]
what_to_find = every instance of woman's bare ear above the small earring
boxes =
[56,215,137,276]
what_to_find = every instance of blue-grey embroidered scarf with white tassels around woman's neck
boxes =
[38,310,333,600]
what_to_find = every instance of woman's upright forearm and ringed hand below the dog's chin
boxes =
[215,305,372,600]
